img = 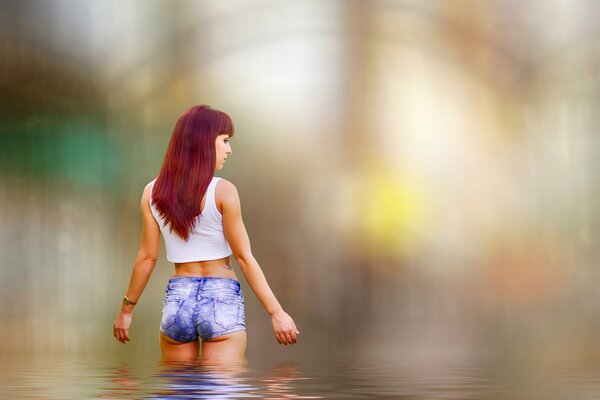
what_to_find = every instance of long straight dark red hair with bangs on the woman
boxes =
[152,105,234,241]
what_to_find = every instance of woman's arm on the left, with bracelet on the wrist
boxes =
[113,185,160,343]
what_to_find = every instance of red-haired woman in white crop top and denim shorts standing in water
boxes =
[113,105,300,361]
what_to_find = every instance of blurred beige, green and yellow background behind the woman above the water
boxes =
[0,0,600,372]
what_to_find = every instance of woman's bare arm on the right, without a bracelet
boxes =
[219,179,300,345]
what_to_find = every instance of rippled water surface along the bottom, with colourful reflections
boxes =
[1,359,600,400]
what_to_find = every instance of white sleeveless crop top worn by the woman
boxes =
[149,176,232,263]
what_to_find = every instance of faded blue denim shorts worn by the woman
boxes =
[160,276,246,342]
